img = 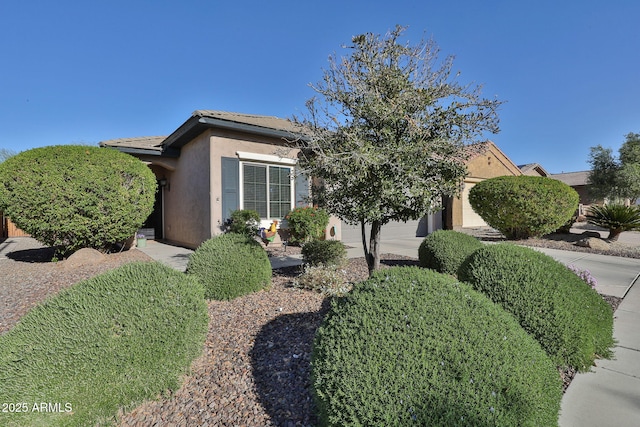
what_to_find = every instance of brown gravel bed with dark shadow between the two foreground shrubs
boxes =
[120,254,417,426]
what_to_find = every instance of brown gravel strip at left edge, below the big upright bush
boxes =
[0,238,151,334]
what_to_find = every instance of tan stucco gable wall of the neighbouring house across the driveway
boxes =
[450,146,522,229]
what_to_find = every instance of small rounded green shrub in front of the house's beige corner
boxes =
[187,233,271,300]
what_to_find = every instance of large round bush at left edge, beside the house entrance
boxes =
[0,145,157,255]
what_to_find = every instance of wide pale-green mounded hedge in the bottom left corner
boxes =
[0,262,208,426]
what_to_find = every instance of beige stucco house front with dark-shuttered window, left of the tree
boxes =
[100,110,340,251]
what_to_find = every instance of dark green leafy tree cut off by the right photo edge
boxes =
[589,133,640,204]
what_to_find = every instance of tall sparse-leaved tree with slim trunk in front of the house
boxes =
[298,26,500,273]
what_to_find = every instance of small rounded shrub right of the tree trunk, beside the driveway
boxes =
[418,230,483,275]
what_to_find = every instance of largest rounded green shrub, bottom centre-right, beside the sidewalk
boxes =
[311,267,562,426]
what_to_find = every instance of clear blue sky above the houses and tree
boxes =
[0,0,640,173]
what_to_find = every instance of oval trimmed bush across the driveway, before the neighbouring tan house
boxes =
[469,175,579,239]
